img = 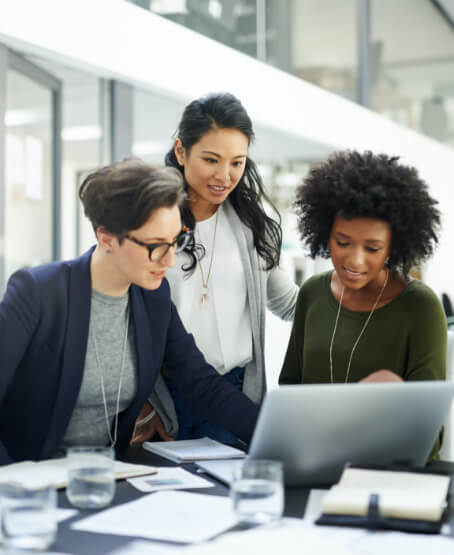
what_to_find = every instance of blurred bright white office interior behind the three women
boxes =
[0,0,454,383]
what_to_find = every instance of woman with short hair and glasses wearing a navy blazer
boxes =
[0,160,258,464]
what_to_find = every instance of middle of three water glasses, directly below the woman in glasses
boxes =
[66,447,115,509]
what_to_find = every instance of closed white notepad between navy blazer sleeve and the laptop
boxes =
[142,437,246,463]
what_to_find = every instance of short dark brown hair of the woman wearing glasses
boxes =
[79,159,184,240]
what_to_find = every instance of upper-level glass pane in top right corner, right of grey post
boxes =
[371,0,454,146]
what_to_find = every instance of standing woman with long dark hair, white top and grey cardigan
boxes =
[135,93,297,444]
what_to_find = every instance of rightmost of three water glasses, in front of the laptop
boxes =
[230,459,284,525]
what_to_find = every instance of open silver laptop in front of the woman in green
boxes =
[199,381,454,487]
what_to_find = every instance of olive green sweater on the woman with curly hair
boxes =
[279,271,447,384]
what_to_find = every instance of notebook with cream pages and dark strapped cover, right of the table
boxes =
[316,467,451,533]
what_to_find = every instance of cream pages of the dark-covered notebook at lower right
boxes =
[322,468,450,522]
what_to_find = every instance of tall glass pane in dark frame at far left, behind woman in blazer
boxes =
[5,69,54,276]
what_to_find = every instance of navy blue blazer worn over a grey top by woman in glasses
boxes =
[0,249,258,464]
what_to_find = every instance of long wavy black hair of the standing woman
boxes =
[165,93,282,270]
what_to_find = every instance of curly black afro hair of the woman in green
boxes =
[294,151,440,276]
